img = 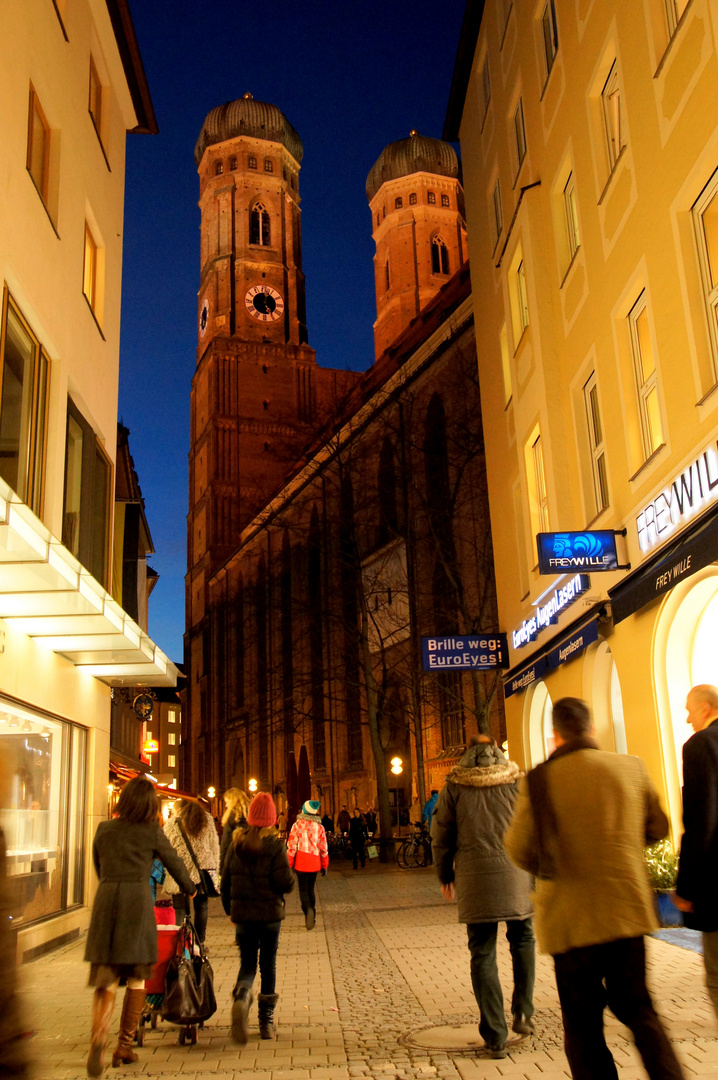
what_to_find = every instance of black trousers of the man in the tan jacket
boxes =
[554,937,683,1080]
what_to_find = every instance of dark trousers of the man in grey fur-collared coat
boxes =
[466,919,536,1047]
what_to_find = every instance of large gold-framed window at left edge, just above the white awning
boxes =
[0,289,50,517]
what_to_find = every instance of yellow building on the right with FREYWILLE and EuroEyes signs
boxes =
[444,0,718,835]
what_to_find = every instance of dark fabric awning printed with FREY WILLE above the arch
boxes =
[608,510,718,625]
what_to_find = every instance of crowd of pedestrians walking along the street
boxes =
[0,686,718,1080]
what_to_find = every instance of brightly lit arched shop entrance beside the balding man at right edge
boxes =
[653,564,718,836]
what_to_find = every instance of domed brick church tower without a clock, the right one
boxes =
[366,131,469,357]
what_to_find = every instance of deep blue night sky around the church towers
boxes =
[120,0,463,661]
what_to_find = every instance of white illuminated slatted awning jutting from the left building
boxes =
[0,480,177,687]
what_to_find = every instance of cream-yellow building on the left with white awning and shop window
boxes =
[0,0,177,959]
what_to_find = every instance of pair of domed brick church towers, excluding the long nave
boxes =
[186,94,468,660]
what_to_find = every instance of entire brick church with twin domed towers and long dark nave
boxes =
[182,97,503,823]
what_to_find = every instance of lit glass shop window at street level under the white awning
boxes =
[0,697,87,926]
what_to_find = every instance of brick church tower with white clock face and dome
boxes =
[184,94,358,789]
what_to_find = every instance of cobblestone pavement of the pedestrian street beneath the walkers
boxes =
[15,864,718,1080]
